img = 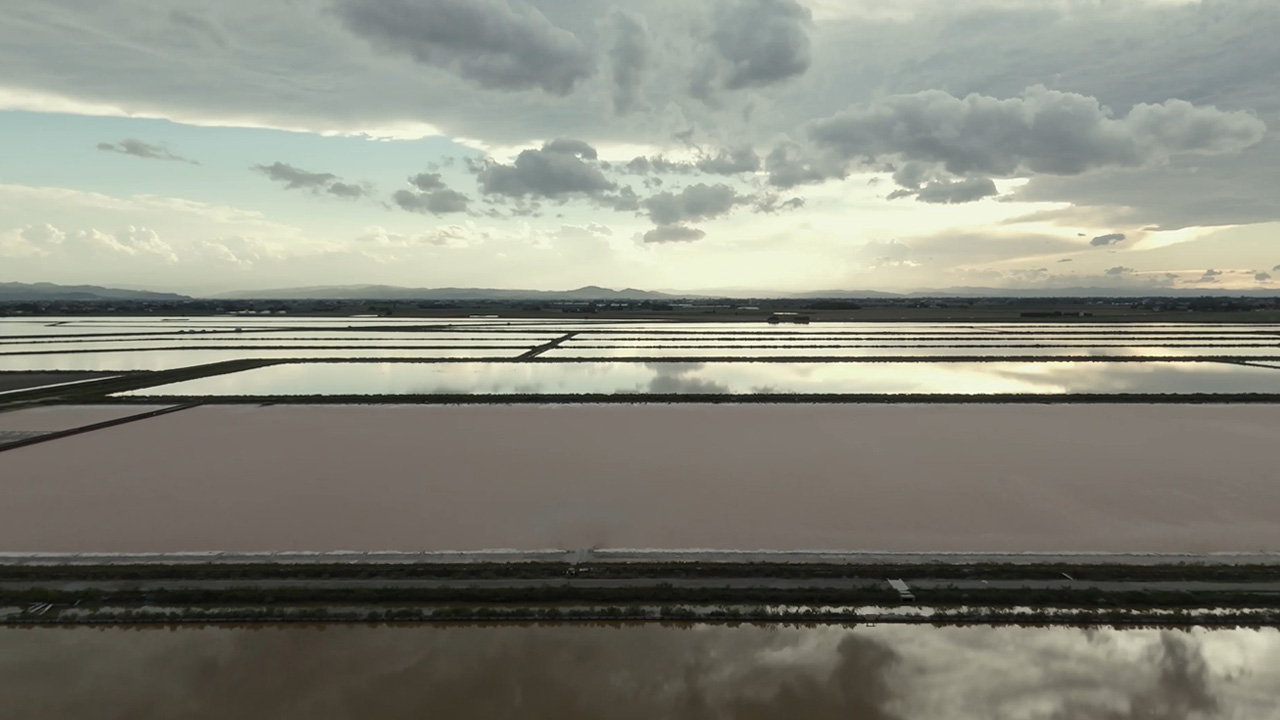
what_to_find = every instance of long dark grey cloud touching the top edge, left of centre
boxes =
[337,0,595,95]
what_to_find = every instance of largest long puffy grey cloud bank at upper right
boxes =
[806,86,1266,185]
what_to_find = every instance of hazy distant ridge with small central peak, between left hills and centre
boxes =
[219,284,694,300]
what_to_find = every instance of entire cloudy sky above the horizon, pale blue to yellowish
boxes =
[0,0,1280,293]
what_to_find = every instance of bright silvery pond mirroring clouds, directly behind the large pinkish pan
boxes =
[122,361,1280,396]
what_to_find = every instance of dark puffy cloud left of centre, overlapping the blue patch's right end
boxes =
[476,138,617,197]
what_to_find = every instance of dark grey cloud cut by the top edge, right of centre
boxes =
[711,0,813,90]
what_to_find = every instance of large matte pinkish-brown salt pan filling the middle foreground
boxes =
[0,399,1280,553]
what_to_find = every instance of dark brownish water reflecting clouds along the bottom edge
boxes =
[0,625,1280,720]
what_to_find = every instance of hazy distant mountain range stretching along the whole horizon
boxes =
[0,282,1280,302]
